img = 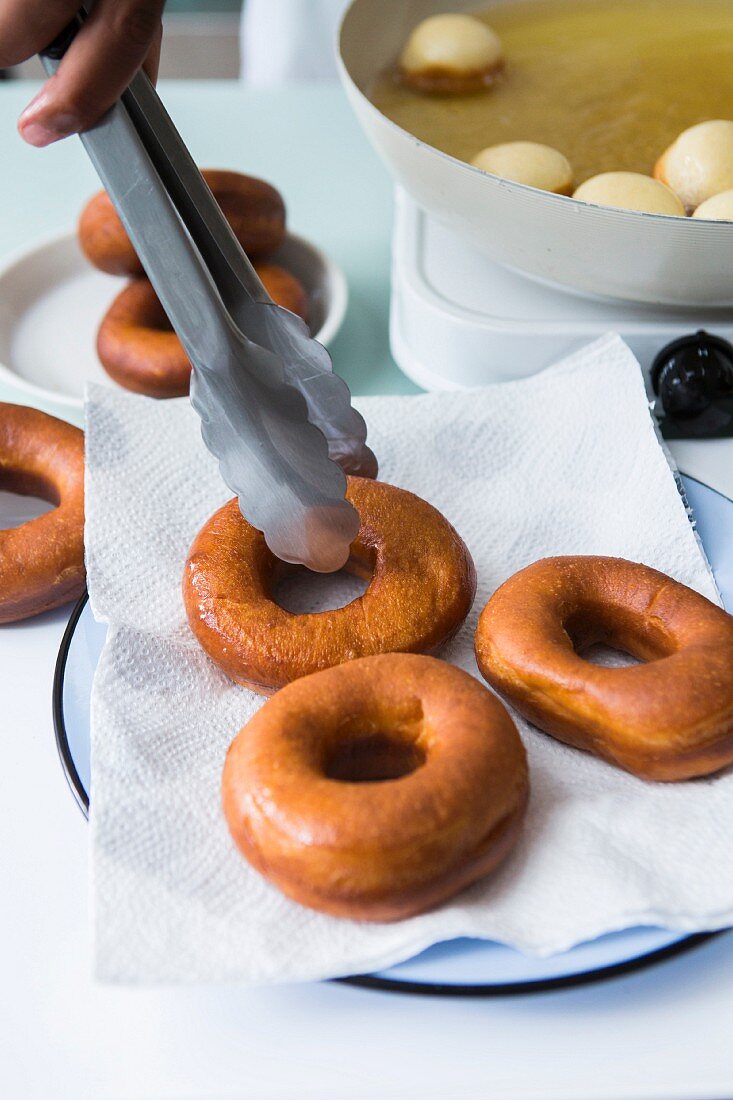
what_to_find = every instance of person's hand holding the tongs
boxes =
[0,0,165,146]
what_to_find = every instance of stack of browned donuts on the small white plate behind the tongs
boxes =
[78,168,309,397]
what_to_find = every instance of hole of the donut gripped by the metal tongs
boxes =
[271,556,374,615]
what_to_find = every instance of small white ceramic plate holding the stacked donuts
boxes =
[0,233,348,408]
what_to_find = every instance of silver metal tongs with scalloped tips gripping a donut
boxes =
[42,14,376,572]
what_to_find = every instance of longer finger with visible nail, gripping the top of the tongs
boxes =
[18,0,164,146]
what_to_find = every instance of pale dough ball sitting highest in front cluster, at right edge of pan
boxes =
[654,119,733,210]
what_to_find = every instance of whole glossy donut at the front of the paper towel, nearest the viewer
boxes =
[222,653,528,921]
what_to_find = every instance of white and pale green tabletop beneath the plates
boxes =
[0,85,733,1100]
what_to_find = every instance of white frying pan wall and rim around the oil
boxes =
[339,0,733,306]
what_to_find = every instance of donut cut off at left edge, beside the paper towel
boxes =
[0,403,85,623]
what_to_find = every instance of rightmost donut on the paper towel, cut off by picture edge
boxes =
[475,557,733,781]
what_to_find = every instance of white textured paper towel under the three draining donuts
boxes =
[82,337,733,981]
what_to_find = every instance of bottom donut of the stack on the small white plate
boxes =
[97,263,308,397]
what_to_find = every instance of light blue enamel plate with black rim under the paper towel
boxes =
[54,477,733,996]
